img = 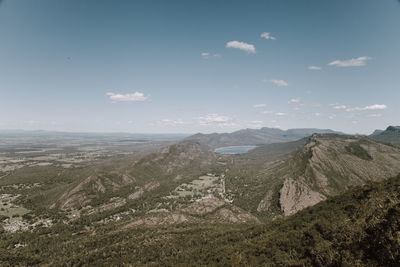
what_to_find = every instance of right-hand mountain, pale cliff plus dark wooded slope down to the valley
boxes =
[226,134,400,217]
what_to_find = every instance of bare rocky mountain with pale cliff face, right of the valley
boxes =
[279,135,400,215]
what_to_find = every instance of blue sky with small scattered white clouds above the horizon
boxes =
[0,0,400,134]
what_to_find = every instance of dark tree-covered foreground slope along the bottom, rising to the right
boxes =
[0,175,400,266]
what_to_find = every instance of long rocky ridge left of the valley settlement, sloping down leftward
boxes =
[51,141,216,210]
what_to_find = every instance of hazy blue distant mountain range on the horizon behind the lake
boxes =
[186,127,343,148]
